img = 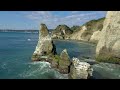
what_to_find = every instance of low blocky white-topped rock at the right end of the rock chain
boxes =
[69,58,93,79]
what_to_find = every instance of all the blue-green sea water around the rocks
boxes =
[0,32,120,79]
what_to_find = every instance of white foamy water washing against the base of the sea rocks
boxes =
[20,61,68,79]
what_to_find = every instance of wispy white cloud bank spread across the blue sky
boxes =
[25,11,106,28]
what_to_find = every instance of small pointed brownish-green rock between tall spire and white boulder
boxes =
[51,49,71,74]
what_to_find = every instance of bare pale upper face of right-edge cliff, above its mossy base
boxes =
[96,11,120,57]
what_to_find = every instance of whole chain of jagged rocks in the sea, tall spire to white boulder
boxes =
[32,24,94,79]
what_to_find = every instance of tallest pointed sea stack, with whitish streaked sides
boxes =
[32,24,56,61]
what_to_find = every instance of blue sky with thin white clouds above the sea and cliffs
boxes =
[0,11,106,30]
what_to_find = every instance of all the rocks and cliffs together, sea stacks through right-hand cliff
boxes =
[32,11,120,79]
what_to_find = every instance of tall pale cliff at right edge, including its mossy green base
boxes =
[96,11,120,63]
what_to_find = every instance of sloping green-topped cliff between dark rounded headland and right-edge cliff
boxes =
[70,18,105,42]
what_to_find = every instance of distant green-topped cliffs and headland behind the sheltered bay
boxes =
[51,18,105,43]
